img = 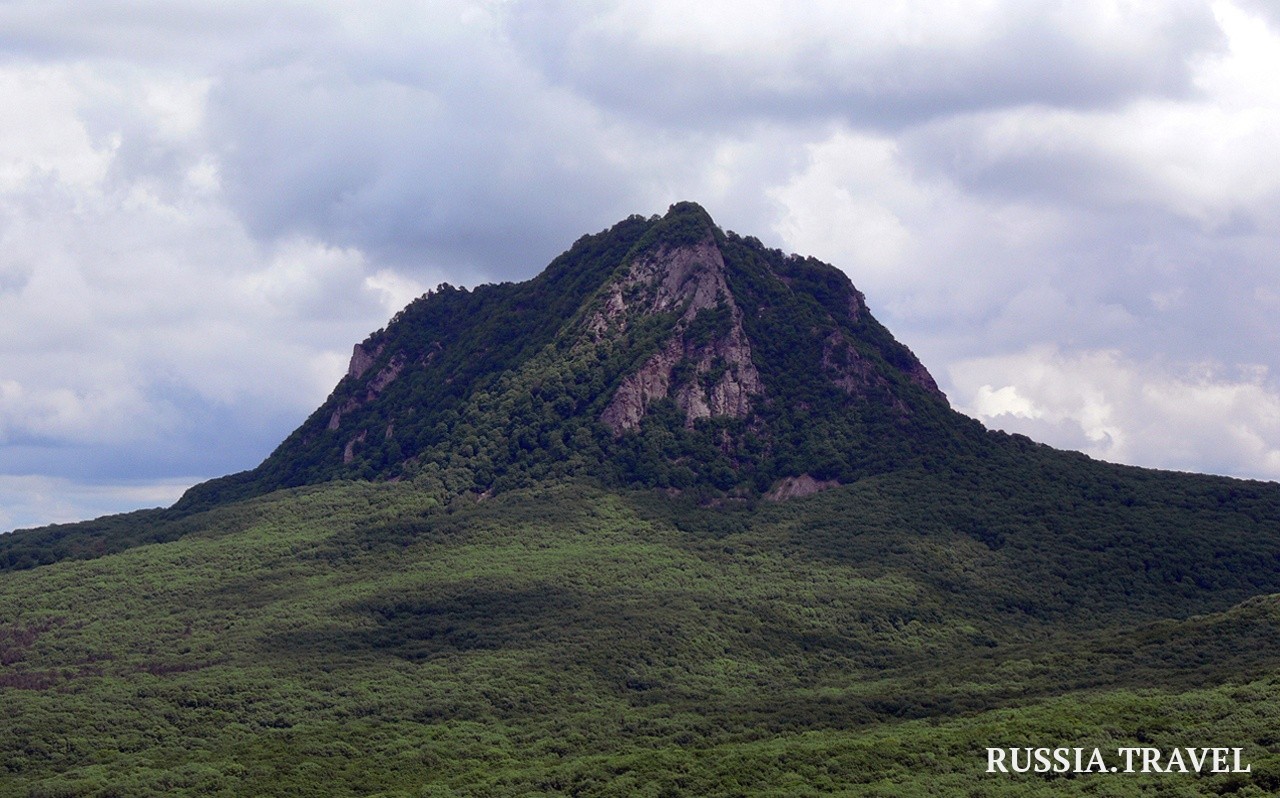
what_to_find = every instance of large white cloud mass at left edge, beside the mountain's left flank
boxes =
[0,59,412,476]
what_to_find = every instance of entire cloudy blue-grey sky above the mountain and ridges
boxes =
[0,0,1280,530]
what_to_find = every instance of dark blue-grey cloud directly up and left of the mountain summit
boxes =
[210,65,650,279]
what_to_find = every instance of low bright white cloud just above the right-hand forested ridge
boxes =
[950,347,1280,479]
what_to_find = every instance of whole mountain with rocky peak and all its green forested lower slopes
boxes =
[0,204,1280,798]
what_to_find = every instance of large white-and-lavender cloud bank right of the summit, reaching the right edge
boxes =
[769,4,1280,404]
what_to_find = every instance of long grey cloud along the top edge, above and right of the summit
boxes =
[509,1,1222,129]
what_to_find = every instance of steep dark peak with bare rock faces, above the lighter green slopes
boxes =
[182,202,962,506]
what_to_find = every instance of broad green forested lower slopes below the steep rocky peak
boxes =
[0,471,1280,795]
